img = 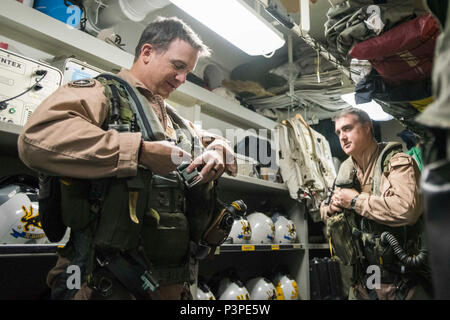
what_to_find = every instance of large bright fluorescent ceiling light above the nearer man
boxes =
[170,0,285,56]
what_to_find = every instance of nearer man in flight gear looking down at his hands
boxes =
[18,18,237,299]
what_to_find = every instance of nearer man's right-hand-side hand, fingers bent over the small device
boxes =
[186,149,225,184]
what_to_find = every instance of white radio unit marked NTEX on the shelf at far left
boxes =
[0,48,62,126]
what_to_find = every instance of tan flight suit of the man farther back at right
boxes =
[320,142,423,300]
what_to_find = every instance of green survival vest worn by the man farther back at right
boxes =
[327,142,424,294]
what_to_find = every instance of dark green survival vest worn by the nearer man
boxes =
[60,75,215,285]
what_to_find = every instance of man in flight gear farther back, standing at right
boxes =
[320,108,432,300]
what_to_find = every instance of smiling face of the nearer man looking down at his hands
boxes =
[141,39,198,99]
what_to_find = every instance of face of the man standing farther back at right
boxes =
[334,114,372,156]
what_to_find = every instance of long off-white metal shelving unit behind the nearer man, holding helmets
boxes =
[0,0,328,299]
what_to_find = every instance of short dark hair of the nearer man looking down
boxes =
[134,17,210,62]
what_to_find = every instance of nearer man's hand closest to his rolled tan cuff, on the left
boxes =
[139,141,192,176]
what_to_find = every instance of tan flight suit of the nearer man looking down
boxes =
[18,69,237,299]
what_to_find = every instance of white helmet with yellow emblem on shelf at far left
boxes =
[0,184,47,244]
